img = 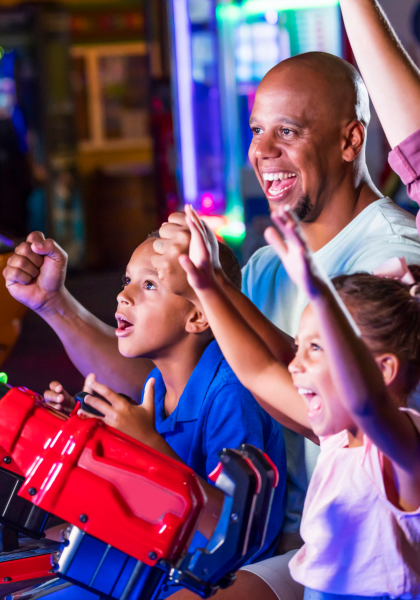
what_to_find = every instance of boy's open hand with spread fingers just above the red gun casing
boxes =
[78,374,160,447]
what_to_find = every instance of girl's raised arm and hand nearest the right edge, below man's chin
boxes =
[266,212,420,510]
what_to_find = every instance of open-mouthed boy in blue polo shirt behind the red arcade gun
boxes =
[46,234,286,593]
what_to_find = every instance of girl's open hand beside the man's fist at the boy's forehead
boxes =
[179,204,216,290]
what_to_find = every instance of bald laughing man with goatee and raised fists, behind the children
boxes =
[4,53,420,600]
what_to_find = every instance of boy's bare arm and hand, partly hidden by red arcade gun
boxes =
[79,374,223,539]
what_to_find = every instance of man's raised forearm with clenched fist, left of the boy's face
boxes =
[3,232,153,400]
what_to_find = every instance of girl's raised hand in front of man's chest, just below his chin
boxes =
[264,205,324,299]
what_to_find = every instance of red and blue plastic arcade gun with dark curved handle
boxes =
[0,383,278,600]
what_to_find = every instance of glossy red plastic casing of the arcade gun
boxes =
[0,388,205,565]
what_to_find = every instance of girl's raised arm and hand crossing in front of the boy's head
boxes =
[179,206,316,439]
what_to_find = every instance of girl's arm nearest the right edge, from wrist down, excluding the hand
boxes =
[311,287,420,510]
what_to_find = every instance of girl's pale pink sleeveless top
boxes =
[289,409,420,599]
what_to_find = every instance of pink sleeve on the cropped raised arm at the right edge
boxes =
[388,129,420,232]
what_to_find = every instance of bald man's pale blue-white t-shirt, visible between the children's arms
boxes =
[242,198,420,532]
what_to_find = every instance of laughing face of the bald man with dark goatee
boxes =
[249,59,362,221]
